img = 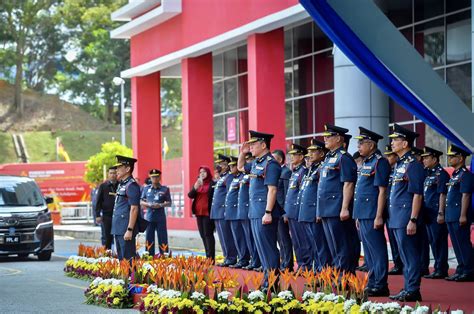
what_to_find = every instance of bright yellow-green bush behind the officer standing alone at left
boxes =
[84,142,133,184]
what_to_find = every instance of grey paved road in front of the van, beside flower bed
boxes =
[0,237,137,313]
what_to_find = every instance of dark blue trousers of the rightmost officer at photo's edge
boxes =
[446,221,474,275]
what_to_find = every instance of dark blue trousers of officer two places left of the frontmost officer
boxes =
[322,217,360,273]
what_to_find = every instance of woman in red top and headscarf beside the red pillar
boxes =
[188,166,216,260]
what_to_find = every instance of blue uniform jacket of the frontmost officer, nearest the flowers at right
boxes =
[388,151,425,229]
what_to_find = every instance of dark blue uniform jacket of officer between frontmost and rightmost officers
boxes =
[423,164,449,223]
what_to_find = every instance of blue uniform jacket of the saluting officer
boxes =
[245,153,282,219]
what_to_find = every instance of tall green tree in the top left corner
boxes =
[0,0,62,115]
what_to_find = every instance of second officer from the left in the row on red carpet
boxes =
[225,156,250,268]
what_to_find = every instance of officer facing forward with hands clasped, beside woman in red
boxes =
[140,169,171,256]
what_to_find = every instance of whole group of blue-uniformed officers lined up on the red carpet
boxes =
[211,124,474,301]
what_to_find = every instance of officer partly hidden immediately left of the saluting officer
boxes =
[237,152,262,271]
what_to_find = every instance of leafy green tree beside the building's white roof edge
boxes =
[56,0,130,122]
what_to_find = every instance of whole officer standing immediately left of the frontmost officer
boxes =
[353,127,391,297]
